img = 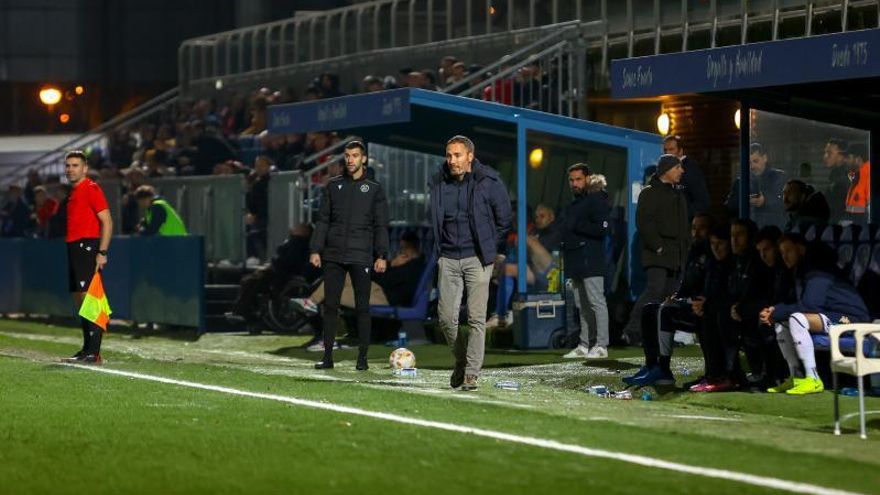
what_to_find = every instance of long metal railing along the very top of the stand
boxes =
[178,0,878,92]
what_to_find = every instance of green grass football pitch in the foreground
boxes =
[0,320,880,495]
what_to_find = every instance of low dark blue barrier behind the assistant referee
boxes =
[0,236,205,329]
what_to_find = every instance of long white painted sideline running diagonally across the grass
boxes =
[61,364,861,495]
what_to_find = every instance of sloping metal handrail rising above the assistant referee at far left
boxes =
[0,88,180,187]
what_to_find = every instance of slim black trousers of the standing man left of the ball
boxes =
[324,261,372,361]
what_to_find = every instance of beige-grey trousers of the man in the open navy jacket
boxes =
[437,256,492,376]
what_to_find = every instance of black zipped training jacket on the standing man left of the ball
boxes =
[309,175,388,266]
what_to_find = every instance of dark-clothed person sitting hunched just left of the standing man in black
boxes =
[225,224,319,323]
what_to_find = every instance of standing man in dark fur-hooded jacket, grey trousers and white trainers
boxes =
[560,167,611,359]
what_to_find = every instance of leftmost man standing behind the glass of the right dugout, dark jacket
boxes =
[727,143,786,227]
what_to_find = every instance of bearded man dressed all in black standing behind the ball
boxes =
[309,141,388,371]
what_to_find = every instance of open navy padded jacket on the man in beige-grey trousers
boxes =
[429,159,513,265]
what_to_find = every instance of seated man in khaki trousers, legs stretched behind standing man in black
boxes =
[291,232,425,316]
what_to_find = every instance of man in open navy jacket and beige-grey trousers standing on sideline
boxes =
[430,136,511,390]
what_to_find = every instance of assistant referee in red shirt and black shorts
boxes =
[64,151,113,364]
